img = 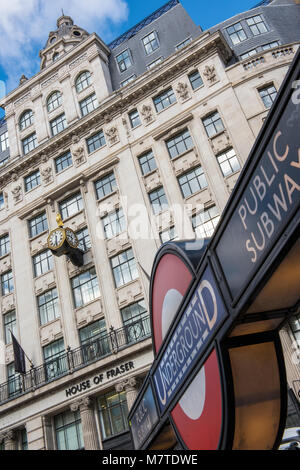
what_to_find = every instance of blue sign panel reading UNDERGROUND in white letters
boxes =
[153,266,227,411]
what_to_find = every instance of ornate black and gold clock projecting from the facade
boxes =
[47,214,83,266]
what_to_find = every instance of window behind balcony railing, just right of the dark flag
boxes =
[43,338,68,380]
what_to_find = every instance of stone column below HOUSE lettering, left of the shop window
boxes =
[70,397,100,450]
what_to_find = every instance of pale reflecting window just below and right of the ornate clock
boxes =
[71,268,100,308]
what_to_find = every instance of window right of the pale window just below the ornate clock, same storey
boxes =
[110,248,139,287]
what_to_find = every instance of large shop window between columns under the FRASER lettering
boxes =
[98,392,128,439]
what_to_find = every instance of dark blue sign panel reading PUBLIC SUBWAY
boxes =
[216,81,300,298]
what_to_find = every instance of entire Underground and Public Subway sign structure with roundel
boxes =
[129,51,300,450]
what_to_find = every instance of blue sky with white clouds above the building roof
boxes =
[0,0,259,117]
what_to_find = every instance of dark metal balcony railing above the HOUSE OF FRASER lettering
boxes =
[0,316,150,405]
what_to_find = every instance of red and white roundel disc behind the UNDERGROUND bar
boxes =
[151,241,222,450]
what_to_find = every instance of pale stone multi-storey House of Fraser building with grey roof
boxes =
[0,0,300,450]
